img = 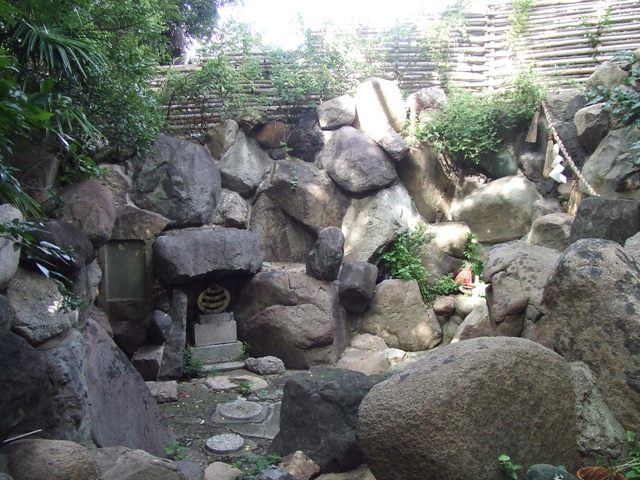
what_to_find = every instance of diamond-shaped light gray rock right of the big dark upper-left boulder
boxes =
[218,132,273,197]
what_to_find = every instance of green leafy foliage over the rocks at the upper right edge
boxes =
[585,51,640,165]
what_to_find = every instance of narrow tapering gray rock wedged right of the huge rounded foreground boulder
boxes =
[571,362,624,458]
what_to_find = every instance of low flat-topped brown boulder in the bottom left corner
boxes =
[6,439,100,480]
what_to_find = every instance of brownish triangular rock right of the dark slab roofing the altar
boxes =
[249,194,315,262]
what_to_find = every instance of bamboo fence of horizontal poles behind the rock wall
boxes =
[158,0,640,135]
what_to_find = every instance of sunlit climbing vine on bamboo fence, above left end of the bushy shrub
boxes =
[423,0,470,85]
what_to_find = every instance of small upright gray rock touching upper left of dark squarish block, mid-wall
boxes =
[307,227,344,282]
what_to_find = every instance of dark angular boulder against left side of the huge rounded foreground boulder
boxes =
[270,368,374,472]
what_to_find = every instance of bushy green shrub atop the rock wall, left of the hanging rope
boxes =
[415,72,544,164]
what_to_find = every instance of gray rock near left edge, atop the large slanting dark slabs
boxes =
[7,269,78,345]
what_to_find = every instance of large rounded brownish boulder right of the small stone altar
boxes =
[233,265,348,368]
